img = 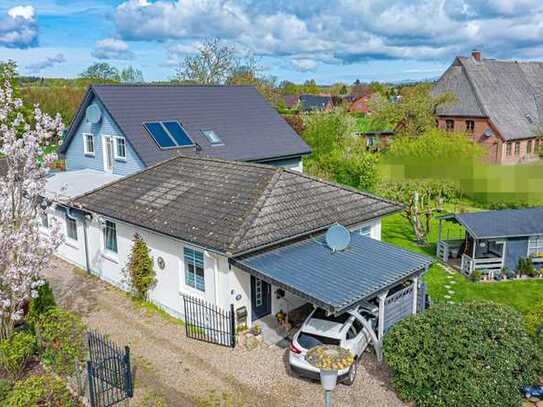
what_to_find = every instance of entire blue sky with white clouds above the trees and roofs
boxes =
[0,0,543,83]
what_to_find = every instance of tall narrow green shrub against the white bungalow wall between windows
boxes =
[128,233,156,300]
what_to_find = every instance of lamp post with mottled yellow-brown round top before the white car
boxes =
[305,345,354,407]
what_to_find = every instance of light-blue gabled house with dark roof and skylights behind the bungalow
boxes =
[60,85,311,176]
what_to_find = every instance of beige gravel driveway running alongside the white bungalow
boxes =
[46,259,404,407]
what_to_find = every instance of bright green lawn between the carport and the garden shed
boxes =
[382,210,543,314]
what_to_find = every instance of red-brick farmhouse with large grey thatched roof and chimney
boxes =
[433,51,543,164]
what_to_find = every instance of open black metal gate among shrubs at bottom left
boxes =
[87,332,134,407]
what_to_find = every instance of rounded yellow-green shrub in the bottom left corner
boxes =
[2,375,77,407]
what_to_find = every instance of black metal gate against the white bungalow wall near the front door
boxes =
[183,295,236,348]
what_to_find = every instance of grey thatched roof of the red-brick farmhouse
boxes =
[433,57,543,140]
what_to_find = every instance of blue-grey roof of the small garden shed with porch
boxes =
[440,208,543,239]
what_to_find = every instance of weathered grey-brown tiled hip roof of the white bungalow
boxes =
[74,156,401,255]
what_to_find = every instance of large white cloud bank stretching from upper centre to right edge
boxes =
[115,0,543,65]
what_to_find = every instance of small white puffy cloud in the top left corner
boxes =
[0,6,38,48]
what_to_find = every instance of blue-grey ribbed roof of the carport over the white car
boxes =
[230,233,433,314]
